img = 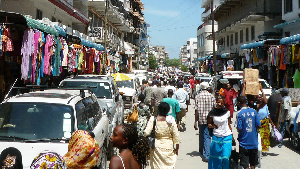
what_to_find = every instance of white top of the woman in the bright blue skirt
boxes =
[213,111,232,137]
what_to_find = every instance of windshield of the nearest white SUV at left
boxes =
[0,102,74,140]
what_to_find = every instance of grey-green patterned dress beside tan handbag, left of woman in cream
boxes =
[130,104,151,136]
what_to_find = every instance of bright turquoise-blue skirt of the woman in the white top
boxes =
[208,135,232,169]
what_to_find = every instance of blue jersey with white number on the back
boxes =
[237,107,261,149]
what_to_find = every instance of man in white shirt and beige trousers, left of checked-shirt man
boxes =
[173,83,189,131]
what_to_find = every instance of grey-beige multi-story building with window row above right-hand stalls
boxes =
[209,0,281,57]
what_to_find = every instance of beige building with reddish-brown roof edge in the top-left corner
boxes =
[0,0,90,33]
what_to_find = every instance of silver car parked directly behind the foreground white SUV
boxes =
[59,75,124,139]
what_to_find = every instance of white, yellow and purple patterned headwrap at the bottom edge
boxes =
[30,151,67,169]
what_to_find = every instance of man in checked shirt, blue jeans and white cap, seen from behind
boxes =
[194,82,216,162]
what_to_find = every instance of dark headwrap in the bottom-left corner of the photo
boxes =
[0,147,23,169]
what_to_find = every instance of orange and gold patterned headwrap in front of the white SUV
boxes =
[64,130,100,169]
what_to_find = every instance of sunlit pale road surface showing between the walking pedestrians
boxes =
[176,101,300,169]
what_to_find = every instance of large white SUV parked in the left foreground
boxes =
[0,89,109,169]
